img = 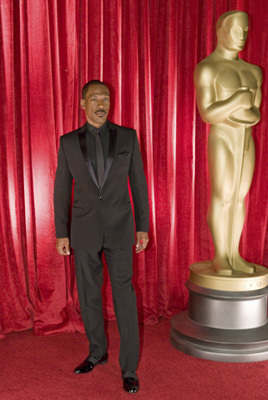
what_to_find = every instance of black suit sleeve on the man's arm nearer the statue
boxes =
[129,131,149,232]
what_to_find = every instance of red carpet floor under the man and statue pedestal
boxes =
[0,320,268,400]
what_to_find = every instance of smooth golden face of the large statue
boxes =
[221,13,248,51]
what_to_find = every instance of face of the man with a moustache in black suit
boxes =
[80,84,110,128]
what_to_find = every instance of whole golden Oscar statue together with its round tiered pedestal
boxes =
[170,11,268,362]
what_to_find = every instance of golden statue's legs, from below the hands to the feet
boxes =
[208,126,255,275]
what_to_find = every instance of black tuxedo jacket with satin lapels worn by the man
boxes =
[54,122,149,250]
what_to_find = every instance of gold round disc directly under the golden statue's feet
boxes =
[190,261,268,292]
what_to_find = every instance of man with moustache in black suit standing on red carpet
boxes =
[54,80,149,393]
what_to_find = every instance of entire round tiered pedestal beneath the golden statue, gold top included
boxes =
[170,262,268,362]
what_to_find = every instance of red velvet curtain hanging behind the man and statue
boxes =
[0,0,268,334]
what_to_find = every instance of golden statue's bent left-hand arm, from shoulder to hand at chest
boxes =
[194,63,252,124]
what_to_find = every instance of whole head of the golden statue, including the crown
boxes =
[217,11,248,51]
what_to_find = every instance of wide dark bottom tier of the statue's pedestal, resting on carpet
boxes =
[170,311,268,362]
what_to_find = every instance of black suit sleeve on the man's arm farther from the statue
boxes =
[54,138,73,238]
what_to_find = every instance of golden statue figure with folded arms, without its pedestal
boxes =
[195,11,262,275]
